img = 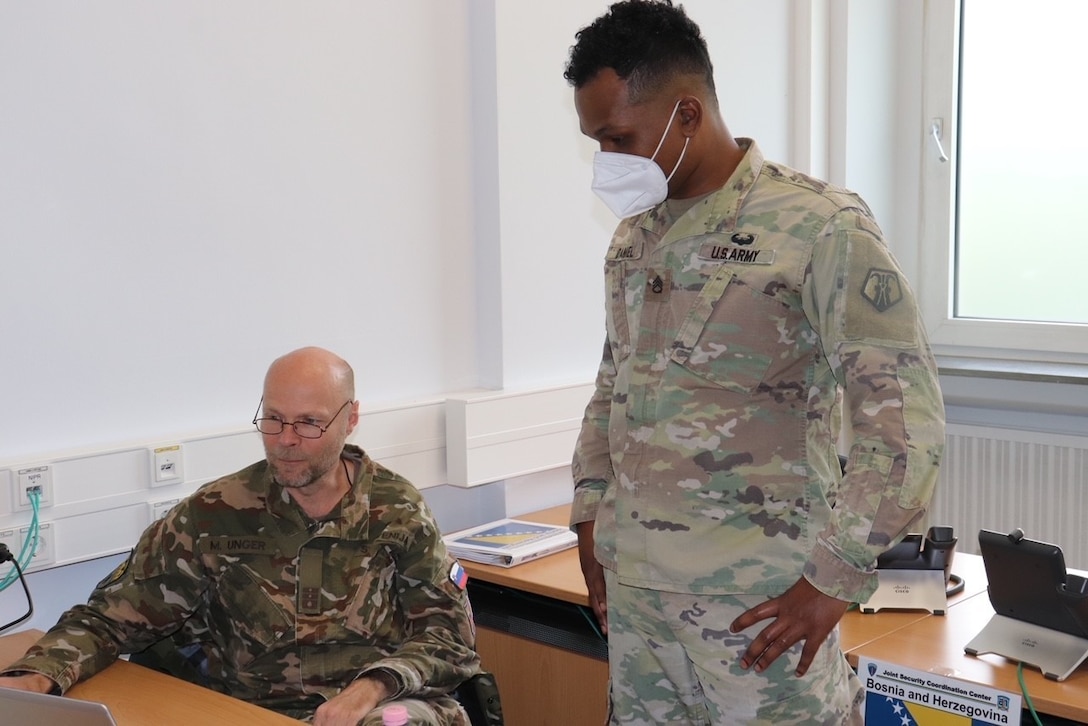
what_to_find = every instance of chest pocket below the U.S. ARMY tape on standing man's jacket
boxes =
[666,263,789,394]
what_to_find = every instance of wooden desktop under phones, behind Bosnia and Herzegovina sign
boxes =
[848,592,1088,723]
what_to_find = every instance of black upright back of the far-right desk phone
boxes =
[978,529,1088,638]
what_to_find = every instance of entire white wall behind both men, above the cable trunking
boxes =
[0,0,822,462]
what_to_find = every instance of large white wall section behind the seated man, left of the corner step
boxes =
[0,0,474,457]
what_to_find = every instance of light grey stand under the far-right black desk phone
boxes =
[963,615,1088,680]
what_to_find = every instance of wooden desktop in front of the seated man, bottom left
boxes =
[0,630,299,726]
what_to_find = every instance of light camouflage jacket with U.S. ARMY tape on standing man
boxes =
[571,139,944,601]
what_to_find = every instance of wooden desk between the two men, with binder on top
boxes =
[461,505,608,726]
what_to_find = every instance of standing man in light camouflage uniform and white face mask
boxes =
[565,0,944,726]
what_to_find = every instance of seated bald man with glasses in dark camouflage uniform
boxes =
[0,348,479,725]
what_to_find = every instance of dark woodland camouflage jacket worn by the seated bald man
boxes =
[1,446,479,717]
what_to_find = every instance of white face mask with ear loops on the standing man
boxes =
[591,101,691,219]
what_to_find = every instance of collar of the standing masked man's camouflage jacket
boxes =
[639,138,764,246]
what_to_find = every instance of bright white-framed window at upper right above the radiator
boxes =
[919,0,1088,361]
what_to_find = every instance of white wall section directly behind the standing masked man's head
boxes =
[489,0,791,387]
